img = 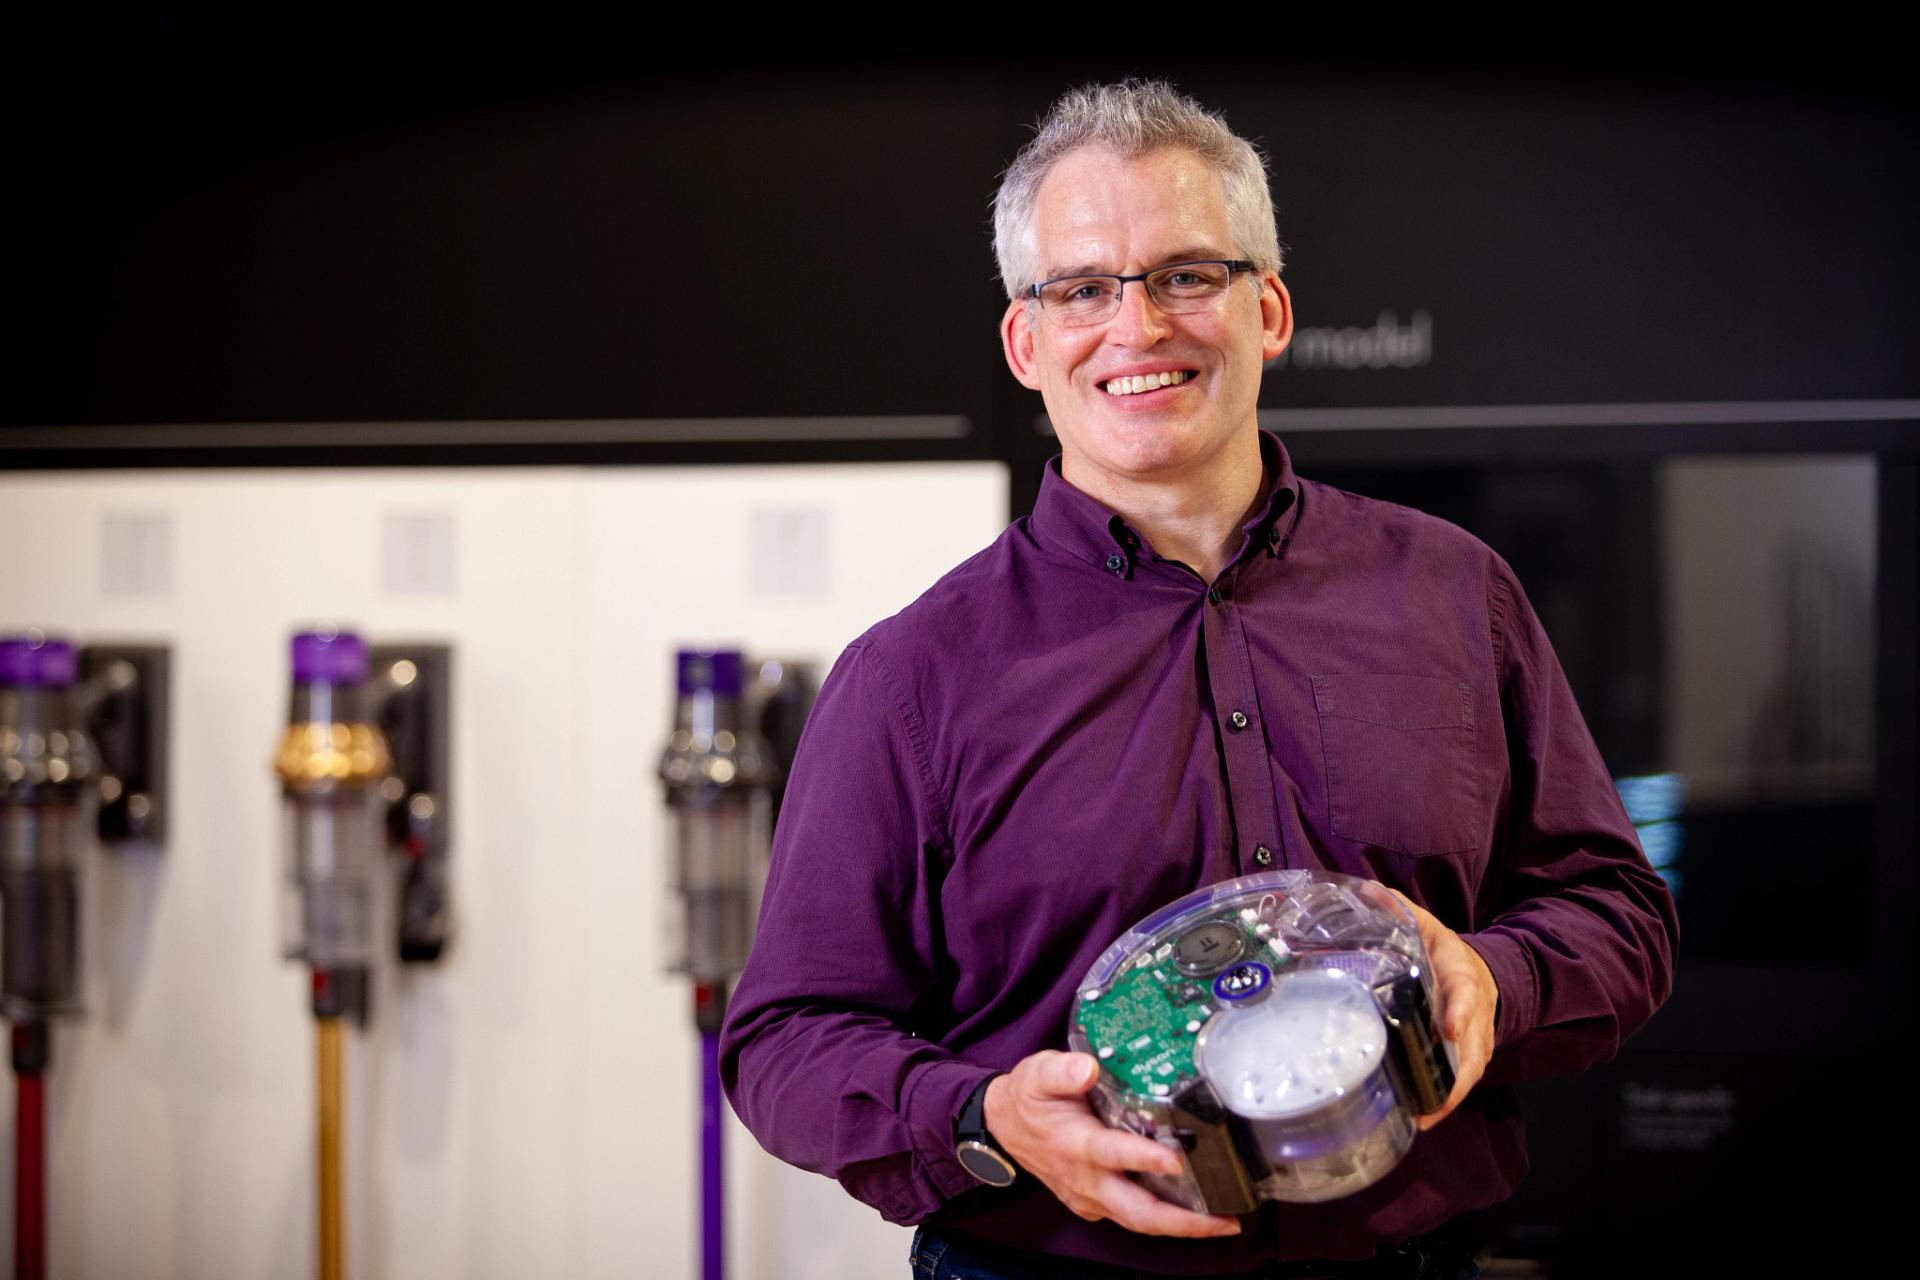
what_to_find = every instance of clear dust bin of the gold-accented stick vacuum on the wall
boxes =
[280,787,384,969]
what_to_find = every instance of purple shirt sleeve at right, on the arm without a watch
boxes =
[1465,562,1680,1084]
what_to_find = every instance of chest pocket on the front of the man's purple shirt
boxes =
[1311,676,1484,854]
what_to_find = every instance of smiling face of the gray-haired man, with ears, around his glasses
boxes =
[1000,148,1292,491]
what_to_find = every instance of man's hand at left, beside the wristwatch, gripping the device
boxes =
[987,1050,1240,1236]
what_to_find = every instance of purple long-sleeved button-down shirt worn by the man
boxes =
[722,434,1676,1274]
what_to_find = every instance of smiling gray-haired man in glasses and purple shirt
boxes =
[722,83,1674,1276]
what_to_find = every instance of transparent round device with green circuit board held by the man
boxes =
[1068,871,1453,1215]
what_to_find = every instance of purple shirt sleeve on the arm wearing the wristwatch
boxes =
[720,639,993,1222]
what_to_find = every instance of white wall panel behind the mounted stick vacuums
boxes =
[0,464,1006,1280]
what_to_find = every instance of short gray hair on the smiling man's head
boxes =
[993,81,1281,297]
